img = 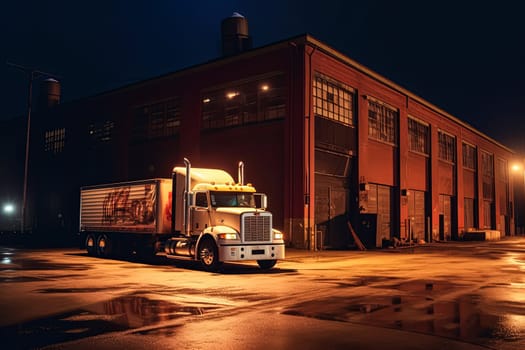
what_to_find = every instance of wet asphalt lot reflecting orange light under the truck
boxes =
[0,237,525,350]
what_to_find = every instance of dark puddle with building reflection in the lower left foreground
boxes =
[0,295,211,349]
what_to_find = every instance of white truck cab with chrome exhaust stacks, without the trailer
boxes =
[165,159,284,270]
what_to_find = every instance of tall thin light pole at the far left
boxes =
[6,62,57,233]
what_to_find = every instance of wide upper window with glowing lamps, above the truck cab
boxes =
[201,74,286,129]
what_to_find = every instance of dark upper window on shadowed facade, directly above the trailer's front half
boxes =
[133,98,181,140]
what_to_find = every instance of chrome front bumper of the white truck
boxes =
[219,243,284,261]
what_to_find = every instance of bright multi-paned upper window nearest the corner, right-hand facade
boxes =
[313,74,354,125]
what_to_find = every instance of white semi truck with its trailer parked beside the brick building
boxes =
[79,158,285,271]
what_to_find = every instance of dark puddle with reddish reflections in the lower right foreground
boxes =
[284,280,525,346]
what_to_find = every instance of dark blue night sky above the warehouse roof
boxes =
[0,0,525,152]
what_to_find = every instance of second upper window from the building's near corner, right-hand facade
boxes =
[368,98,398,145]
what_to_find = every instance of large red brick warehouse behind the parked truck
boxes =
[28,16,514,248]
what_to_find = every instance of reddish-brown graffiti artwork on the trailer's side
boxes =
[102,184,155,225]
